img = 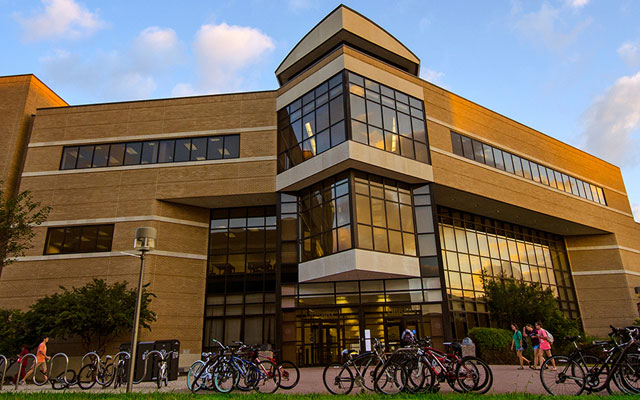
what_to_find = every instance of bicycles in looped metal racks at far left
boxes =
[0,350,178,390]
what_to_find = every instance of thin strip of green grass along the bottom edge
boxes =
[0,392,631,400]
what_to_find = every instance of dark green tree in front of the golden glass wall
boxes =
[484,277,580,346]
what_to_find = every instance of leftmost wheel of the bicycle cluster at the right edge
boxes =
[540,356,586,396]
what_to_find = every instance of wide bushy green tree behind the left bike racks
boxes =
[0,279,156,354]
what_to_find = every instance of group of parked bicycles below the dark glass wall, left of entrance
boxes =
[187,339,300,393]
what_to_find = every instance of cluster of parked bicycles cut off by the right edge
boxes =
[540,326,640,395]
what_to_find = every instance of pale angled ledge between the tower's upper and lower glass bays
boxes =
[276,140,433,192]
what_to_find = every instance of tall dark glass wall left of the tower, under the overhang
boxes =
[203,206,277,351]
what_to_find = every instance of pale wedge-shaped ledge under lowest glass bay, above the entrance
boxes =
[298,249,420,282]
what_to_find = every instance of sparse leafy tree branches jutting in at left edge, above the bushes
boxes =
[0,181,51,278]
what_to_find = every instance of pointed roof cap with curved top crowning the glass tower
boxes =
[276,4,420,85]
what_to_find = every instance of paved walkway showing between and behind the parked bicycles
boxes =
[2,365,620,394]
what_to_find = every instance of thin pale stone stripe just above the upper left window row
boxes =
[28,126,278,147]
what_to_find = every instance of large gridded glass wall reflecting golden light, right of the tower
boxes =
[438,207,579,339]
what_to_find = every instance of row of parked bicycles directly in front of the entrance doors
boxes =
[323,337,493,394]
